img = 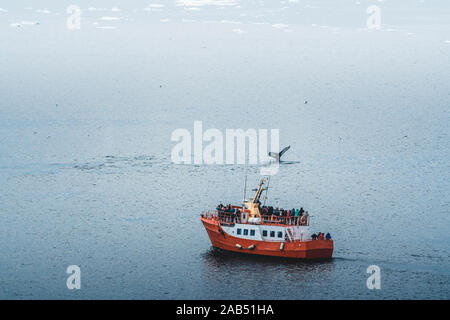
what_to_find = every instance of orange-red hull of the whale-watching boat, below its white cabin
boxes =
[201,217,333,259]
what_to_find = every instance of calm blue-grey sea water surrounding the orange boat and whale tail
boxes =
[0,1,450,299]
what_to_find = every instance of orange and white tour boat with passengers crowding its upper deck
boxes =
[201,178,333,259]
